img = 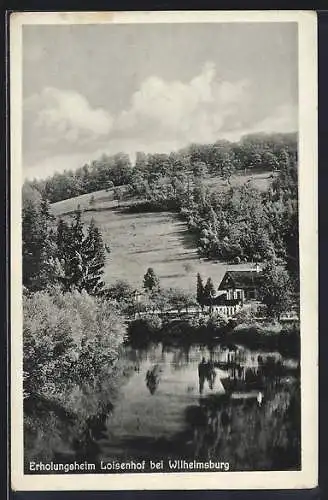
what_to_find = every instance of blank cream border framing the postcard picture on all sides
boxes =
[10,11,318,491]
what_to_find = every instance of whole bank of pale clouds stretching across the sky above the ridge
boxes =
[23,62,298,177]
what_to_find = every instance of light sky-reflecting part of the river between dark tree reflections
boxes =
[94,343,297,470]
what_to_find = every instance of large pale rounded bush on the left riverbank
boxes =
[23,289,125,411]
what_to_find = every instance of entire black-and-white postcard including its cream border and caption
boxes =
[10,11,317,489]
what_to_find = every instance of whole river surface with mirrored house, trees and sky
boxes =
[23,343,300,470]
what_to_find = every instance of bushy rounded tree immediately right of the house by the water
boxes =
[259,260,292,318]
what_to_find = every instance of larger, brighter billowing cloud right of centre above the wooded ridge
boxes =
[116,62,249,142]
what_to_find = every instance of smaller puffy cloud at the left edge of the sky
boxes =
[24,87,113,143]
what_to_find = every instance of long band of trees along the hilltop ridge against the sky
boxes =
[28,134,297,203]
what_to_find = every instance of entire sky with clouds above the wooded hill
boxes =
[23,22,298,178]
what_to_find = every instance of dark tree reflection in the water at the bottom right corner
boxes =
[184,380,301,470]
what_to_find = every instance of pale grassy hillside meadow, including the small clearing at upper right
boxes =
[52,172,270,293]
